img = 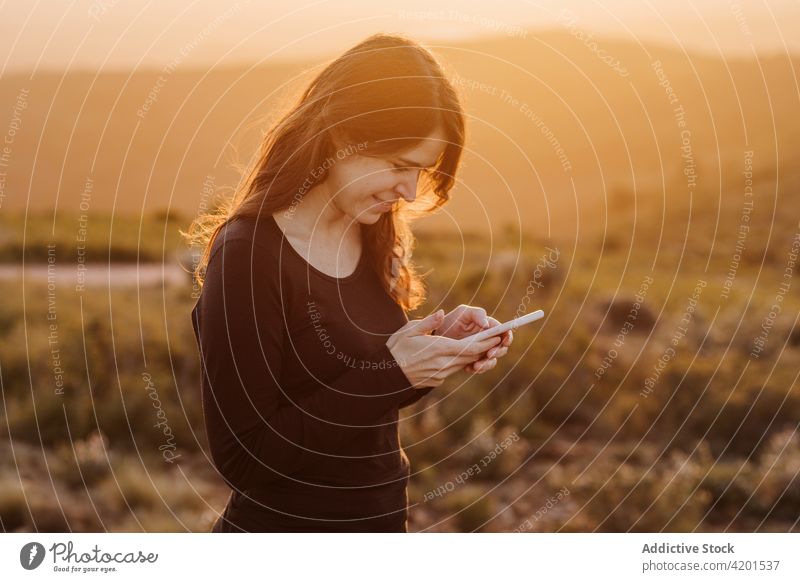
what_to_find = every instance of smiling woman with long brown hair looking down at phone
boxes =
[189,35,513,532]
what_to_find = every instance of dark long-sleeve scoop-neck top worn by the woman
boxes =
[192,214,431,531]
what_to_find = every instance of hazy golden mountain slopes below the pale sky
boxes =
[0,31,800,244]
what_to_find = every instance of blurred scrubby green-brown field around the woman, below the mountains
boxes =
[0,206,800,531]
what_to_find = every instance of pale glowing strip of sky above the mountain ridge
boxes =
[0,0,800,73]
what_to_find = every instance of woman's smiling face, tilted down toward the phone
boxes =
[326,129,447,224]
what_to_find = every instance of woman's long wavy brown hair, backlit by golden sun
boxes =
[182,34,464,312]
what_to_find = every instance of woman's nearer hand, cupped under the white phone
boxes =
[386,309,503,388]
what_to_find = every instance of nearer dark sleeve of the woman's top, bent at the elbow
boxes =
[196,239,417,489]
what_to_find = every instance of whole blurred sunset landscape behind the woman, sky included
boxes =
[0,0,800,532]
